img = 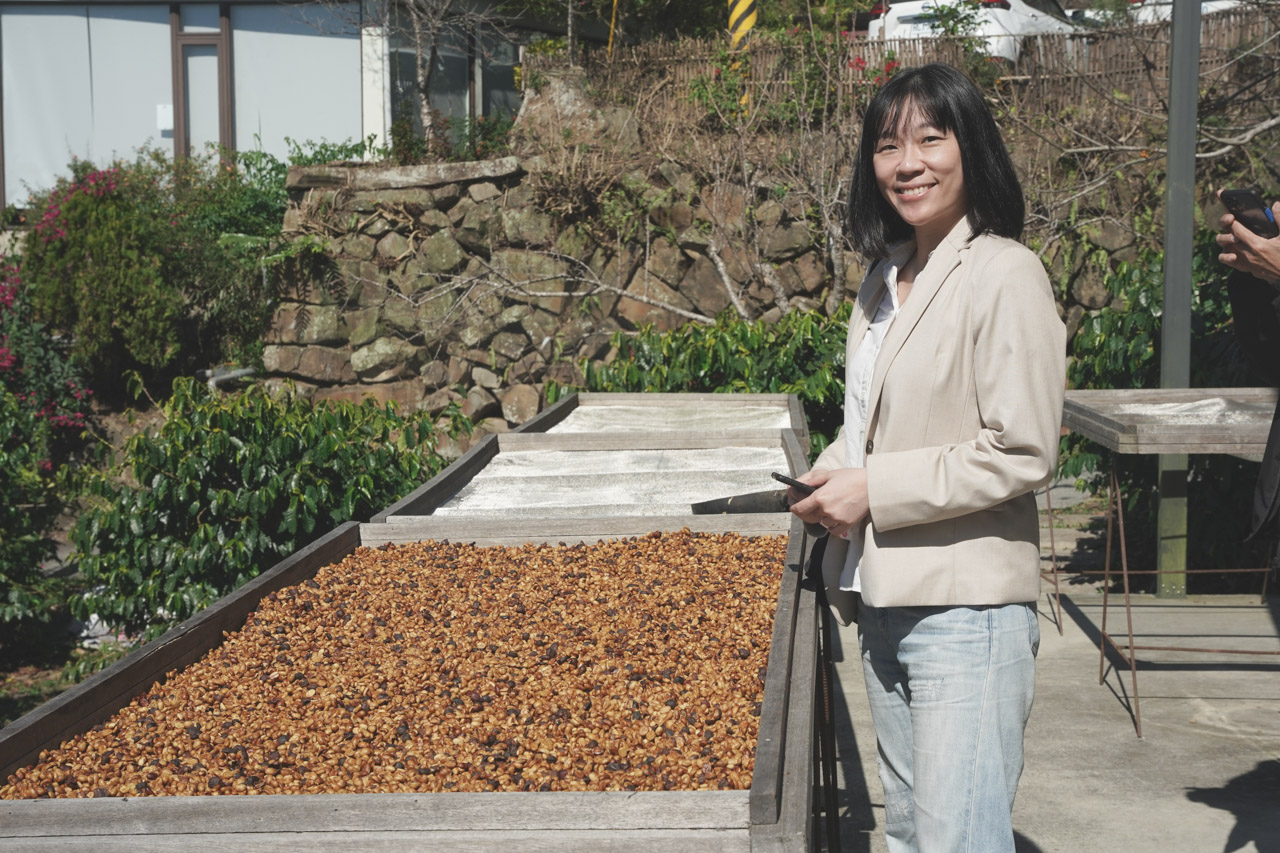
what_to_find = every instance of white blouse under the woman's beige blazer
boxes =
[840,254,910,592]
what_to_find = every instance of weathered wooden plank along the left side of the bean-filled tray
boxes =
[0,521,360,779]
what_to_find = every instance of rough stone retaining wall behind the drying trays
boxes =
[264,158,829,432]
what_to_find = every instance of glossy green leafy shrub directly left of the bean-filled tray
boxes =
[73,379,460,634]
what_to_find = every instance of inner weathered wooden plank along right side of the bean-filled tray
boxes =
[750,514,808,825]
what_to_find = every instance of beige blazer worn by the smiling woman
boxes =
[810,220,1066,624]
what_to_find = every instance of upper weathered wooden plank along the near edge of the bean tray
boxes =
[0,790,748,841]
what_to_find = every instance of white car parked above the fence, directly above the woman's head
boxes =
[867,0,1079,61]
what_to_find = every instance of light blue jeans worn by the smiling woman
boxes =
[858,603,1039,853]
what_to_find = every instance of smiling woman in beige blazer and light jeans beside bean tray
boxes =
[791,64,1066,853]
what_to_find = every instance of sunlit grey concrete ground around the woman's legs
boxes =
[819,484,1280,853]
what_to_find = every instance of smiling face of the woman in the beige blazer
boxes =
[872,104,969,241]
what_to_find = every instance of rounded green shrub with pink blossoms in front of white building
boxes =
[23,152,252,391]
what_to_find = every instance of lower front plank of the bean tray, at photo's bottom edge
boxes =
[4,829,751,853]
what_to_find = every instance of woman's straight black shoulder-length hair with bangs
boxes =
[846,63,1025,257]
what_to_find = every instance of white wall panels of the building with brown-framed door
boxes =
[0,4,366,206]
